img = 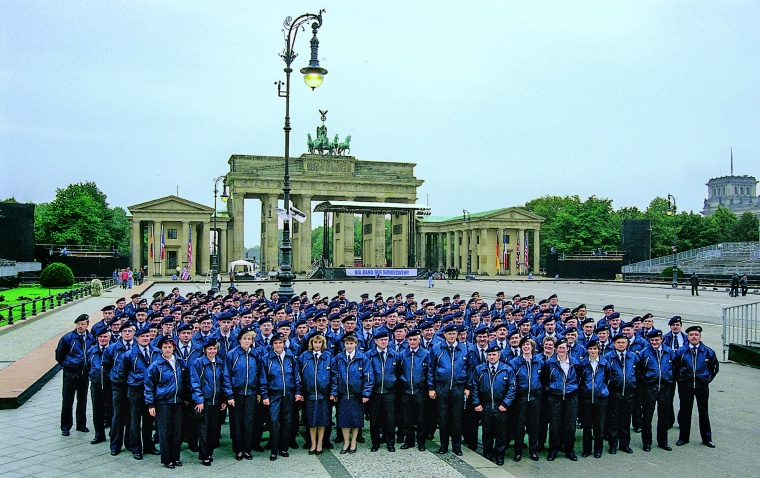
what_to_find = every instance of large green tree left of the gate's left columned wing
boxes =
[34,182,129,254]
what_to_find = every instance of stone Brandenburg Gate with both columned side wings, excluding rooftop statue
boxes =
[128,154,543,277]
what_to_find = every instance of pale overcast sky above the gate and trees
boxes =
[0,0,760,246]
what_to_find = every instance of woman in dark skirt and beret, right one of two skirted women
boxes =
[330,332,373,454]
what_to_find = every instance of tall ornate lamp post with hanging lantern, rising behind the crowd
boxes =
[275,10,327,297]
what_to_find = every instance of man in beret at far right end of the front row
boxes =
[674,325,719,448]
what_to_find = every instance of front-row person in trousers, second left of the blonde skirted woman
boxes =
[224,326,261,461]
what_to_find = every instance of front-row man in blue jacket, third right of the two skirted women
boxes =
[428,323,469,456]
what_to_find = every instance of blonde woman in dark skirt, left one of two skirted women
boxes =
[298,333,332,455]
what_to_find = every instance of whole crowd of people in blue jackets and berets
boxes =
[56,288,718,468]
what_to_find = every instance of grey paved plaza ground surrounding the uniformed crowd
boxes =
[0,280,760,477]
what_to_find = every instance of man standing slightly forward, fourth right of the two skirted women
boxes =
[468,345,517,465]
